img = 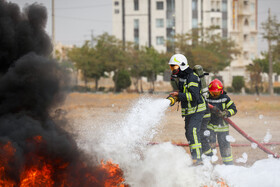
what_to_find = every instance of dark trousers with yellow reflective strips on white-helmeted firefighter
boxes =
[185,111,205,161]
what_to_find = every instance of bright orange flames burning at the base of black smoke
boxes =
[0,136,128,187]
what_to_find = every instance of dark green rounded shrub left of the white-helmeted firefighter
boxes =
[113,70,131,92]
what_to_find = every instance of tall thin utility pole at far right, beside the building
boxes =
[267,8,273,95]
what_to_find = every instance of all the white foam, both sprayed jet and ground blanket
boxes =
[74,97,280,187]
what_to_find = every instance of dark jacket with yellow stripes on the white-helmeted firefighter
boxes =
[178,68,206,116]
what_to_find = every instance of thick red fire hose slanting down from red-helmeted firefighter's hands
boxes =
[208,104,280,158]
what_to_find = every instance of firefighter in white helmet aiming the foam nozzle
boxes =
[169,54,206,165]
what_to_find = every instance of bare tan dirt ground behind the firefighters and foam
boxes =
[56,93,280,166]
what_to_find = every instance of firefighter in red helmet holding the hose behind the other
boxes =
[204,79,237,165]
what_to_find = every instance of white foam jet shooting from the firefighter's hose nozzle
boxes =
[98,97,170,163]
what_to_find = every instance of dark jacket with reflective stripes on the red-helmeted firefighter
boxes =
[206,91,237,132]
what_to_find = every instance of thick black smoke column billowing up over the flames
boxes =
[0,0,115,186]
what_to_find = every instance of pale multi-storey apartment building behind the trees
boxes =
[113,0,258,86]
